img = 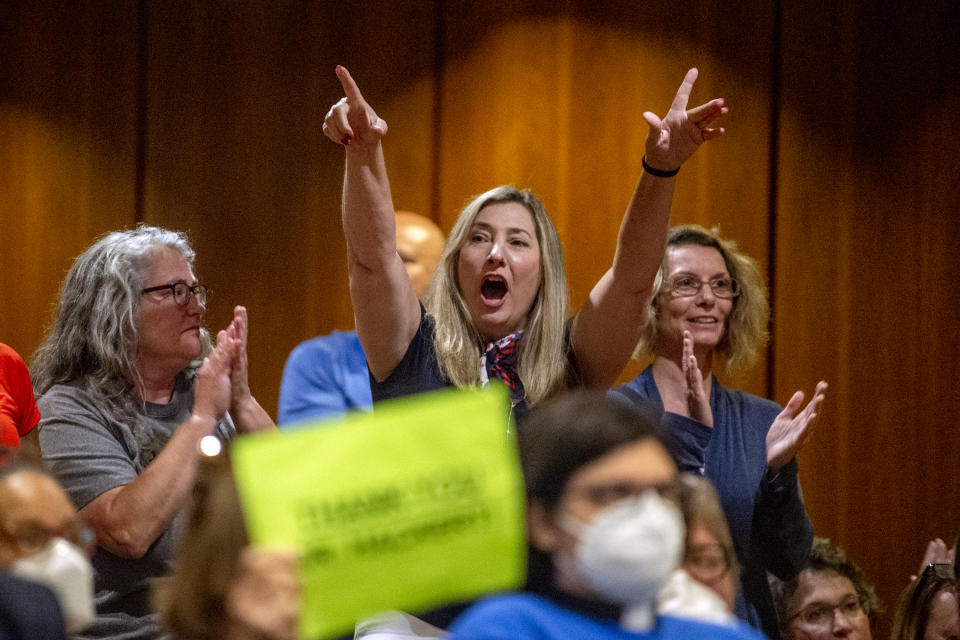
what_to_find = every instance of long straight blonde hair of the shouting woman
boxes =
[425,186,569,404]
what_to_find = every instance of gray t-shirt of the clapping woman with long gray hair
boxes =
[37,383,236,640]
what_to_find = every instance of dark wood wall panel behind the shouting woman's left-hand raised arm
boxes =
[144,2,434,413]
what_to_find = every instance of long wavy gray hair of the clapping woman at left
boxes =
[30,224,210,419]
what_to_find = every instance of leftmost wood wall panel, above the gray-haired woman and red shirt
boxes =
[0,2,137,360]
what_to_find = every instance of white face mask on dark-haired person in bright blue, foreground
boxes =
[558,489,685,606]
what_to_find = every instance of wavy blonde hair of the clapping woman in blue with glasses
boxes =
[635,224,770,374]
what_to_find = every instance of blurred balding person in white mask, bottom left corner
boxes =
[0,461,94,640]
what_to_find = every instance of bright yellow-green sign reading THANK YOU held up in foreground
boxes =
[232,385,526,638]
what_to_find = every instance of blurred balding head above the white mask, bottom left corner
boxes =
[0,469,77,567]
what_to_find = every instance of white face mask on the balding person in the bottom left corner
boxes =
[10,538,95,633]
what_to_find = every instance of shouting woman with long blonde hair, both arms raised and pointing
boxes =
[323,67,726,410]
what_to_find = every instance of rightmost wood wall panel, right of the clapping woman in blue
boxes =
[775,2,960,628]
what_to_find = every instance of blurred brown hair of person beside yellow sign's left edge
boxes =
[153,453,248,640]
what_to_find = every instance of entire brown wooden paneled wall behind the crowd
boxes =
[0,0,960,636]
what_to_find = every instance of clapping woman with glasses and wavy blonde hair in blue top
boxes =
[611,225,827,639]
